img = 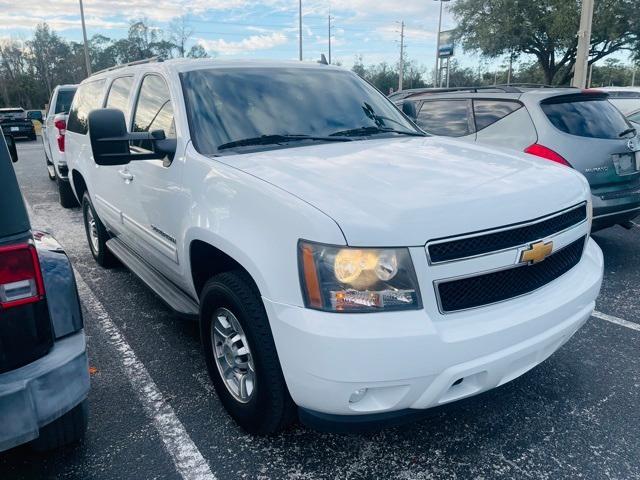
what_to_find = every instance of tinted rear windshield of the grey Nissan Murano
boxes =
[540,94,629,139]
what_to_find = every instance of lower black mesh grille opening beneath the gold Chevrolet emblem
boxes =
[436,237,585,313]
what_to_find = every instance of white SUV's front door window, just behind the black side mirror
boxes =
[131,75,176,150]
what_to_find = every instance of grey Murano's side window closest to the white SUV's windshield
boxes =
[417,100,471,137]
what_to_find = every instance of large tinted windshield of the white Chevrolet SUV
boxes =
[181,67,420,155]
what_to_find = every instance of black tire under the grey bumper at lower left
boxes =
[31,399,89,452]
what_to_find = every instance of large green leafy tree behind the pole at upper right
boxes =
[451,0,640,84]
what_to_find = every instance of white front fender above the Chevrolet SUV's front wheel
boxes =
[179,148,346,306]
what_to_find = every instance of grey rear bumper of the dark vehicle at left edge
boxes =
[0,331,89,451]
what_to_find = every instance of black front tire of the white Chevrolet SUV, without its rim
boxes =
[200,271,297,435]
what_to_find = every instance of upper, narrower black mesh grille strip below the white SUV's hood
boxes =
[428,203,587,263]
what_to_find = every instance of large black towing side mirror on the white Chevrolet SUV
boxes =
[88,108,175,165]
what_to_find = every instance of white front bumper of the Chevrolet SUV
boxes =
[264,239,603,415]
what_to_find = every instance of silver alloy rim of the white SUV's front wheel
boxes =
[211,308,256,403]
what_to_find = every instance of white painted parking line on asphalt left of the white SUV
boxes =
[75,271,216,480]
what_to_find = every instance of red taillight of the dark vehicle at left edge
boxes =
[0,243,44,308]
